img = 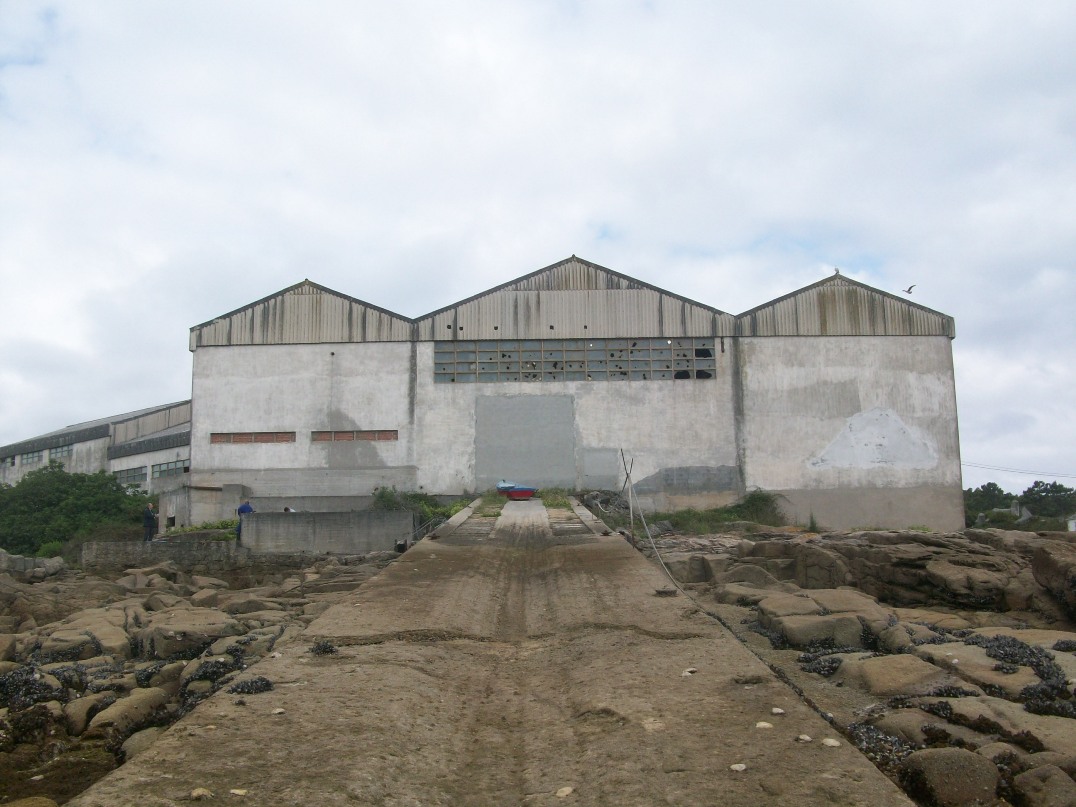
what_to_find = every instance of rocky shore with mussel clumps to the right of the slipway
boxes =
[654,525,1076,807]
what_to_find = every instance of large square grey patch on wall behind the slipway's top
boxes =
[475,395,576,491]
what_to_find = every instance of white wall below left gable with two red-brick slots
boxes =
[190,342,415,496]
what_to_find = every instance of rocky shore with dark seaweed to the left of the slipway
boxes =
[0,552,396,807]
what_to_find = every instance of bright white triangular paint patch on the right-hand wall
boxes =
[807,407,938,469]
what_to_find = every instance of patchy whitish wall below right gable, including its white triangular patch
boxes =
[739,337,963,529]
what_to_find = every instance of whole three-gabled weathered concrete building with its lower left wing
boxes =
[0,256,963,529]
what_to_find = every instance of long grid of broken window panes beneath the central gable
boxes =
[434,337,717,383]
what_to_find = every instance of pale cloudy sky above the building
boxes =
[0,0,1076,493]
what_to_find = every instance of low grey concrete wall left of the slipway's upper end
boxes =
[242,510,416,554]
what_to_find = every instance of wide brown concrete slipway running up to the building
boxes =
[69,500,911,807]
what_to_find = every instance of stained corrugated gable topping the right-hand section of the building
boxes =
[736,275,957,339]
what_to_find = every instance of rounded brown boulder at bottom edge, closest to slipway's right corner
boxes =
[901,748,1001,807]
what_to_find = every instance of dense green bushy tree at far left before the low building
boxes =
[0,462,148,555]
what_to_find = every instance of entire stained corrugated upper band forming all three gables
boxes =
[190,255,955,350]
